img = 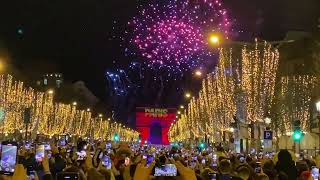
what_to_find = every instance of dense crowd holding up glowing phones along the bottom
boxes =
[0,139,319,180]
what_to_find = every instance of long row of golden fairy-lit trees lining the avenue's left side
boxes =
[0,75,139,140]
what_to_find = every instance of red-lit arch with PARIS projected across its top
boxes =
[136,107,176,145]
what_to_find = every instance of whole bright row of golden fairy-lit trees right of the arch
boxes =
[170,42,279,142]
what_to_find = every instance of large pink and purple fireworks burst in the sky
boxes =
[128,0,231,70]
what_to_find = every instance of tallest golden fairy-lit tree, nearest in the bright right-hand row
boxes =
[240,40,279,122]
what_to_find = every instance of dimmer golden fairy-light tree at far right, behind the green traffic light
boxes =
[274,75,318,135]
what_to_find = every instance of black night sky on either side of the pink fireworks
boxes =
[0,0,320,104]
